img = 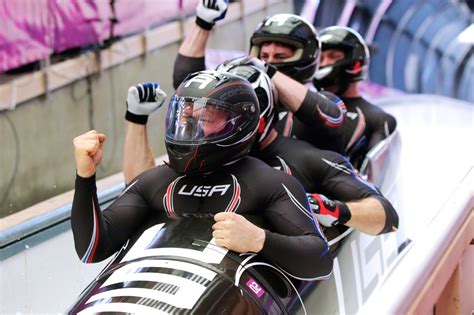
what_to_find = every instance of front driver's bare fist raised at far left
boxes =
[73,130,105,178]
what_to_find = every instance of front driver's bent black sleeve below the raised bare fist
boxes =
[71,176,148,263]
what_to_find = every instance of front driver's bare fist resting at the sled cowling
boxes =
[212,212,265,253]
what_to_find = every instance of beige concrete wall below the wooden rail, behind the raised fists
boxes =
[0,1,291,218]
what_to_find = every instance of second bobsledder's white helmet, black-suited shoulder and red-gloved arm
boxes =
[218,64,398,234]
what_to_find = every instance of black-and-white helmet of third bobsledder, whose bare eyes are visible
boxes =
[250,14,321,82]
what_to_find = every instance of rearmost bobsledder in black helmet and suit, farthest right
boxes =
[313,26,397,166]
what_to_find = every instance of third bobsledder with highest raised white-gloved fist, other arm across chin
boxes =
[173,10,346,154]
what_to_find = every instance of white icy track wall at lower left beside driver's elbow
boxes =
[0,221,109,314]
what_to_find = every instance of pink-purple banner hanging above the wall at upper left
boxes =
[0,0,198,72]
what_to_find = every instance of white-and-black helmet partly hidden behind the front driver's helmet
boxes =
[216,57,278,143]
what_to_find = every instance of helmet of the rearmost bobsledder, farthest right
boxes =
[313,26,370,93]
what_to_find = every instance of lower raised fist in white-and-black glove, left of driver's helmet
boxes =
[125,82,166,125]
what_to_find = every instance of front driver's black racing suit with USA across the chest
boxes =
[72,157,331,278]
